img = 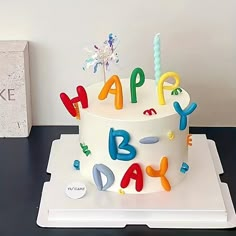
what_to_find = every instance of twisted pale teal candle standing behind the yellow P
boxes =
[153,34,161,84]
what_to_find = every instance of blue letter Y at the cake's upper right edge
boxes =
[173,102,197,130]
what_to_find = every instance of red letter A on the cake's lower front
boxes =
[120,163,143,192]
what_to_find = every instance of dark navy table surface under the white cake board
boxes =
[0,126,236,236]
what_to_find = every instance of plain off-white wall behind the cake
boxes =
[0,0,236,126]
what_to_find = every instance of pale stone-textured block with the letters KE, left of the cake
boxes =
[0,41,32,137]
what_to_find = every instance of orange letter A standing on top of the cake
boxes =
[98,75,123,110]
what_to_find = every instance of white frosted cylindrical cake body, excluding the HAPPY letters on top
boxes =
[79,79,190,194]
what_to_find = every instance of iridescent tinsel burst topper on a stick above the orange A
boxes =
[83,33,119,83]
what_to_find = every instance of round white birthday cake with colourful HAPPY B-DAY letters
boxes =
[60,34,197,194]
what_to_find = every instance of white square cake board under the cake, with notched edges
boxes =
[37,135,236,228]
